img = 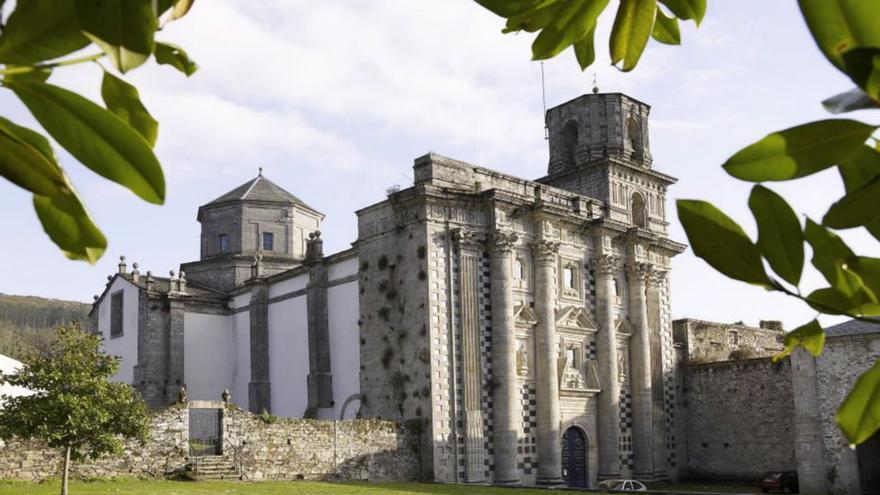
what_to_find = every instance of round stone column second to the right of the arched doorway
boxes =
[626,261,661,479]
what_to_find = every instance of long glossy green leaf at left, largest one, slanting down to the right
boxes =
[7,82,165,204]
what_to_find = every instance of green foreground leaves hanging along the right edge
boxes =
[678,0,880,450]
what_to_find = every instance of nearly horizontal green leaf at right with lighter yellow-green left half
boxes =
[723,119,876,182]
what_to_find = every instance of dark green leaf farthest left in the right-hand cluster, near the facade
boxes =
[676,199,771,286]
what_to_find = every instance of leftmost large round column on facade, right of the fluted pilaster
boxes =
[489,231,522,484]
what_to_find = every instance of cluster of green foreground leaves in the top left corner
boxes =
[0,0,197,263]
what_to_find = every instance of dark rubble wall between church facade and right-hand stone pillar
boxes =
[680,358,796,480]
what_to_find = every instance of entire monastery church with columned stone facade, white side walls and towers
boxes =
[91,93,685,486]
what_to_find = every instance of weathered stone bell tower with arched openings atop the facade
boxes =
[538,88,676,233]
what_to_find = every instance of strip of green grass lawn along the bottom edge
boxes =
[0,479,592,495]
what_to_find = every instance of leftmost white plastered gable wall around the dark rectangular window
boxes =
[98,277,140,384]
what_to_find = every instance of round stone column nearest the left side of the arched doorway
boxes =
[532,241,562,484]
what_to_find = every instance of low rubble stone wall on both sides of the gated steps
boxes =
[0,406,420,481]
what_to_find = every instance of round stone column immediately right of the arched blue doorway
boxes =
[594,254,620,479]
